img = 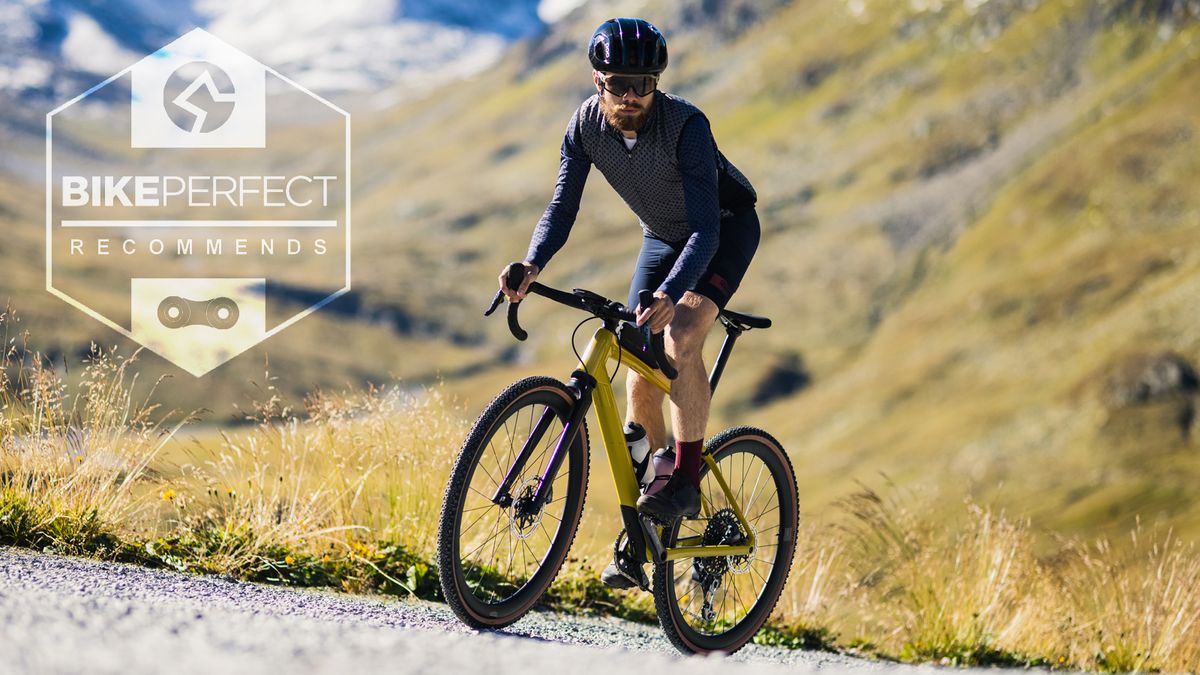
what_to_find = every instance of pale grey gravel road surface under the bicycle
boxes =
[0,548,934,675]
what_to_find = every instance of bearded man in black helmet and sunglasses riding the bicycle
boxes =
[499,18,760,587]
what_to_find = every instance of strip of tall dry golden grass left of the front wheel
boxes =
[0,303,466,574]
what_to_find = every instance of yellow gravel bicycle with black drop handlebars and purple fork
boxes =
[438,263,798,653]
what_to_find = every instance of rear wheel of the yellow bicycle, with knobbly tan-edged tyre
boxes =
[654,426,799,653]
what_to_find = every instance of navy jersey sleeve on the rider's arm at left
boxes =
[526,110,592,269]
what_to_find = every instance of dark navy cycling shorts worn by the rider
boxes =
[629,209,760,310]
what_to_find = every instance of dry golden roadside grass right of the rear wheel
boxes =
[782,489,1200,671]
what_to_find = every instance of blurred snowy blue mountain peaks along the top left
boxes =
[0,0,544,98]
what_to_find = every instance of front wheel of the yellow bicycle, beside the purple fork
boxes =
[438,377,588,628]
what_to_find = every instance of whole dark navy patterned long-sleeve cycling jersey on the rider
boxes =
[526,91,756,303]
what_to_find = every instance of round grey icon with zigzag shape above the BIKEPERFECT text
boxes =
[162,61,235,133]
